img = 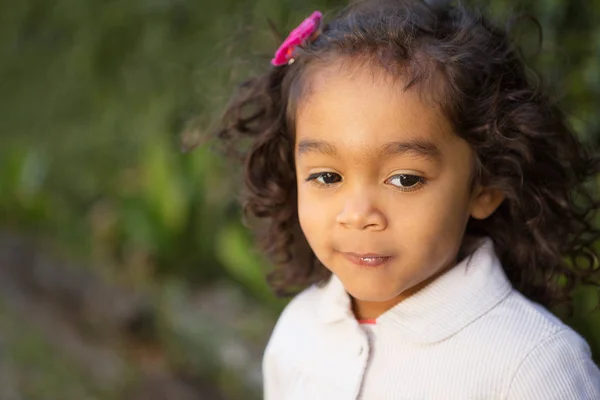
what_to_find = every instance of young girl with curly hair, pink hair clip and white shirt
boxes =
[220,0,600,400]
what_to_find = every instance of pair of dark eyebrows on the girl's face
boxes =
[298,139,442,161]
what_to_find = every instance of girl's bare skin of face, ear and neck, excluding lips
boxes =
[295,64,503,318]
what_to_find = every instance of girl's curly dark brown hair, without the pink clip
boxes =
[218,0,600,307]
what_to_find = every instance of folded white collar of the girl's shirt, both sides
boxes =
[319,238,512,343]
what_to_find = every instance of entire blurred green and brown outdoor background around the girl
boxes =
[0,0,600,400]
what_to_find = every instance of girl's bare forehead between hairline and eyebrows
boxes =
[295,62,455,149]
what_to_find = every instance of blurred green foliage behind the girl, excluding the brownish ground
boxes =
[0,0,600,398]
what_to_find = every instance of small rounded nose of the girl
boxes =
[336,192,387,231]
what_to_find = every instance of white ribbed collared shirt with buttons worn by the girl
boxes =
[263,239,600,400]
